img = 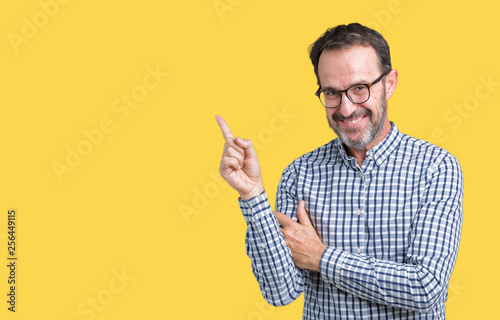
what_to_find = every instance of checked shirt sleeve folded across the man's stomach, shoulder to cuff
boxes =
[320,154,463,312]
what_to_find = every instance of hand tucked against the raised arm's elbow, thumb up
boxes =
[274,200,326,271]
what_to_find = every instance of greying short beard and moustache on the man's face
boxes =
[328,91,387,149]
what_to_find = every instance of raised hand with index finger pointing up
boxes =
[215,116,264,200]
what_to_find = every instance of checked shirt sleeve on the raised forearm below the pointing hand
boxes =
[239,191,306,306]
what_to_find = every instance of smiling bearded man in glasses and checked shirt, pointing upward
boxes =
[217,24,463,319]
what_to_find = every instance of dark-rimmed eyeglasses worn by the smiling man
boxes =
[315,71,390,108]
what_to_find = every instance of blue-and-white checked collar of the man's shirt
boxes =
[335,122,403,165]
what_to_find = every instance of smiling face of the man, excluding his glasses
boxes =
[318,46,392,150]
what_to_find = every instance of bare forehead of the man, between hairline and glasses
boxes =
[318,46,380,89]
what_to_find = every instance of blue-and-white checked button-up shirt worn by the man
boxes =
[239,123,463,320]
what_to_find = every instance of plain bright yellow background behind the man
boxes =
[0,0,500,319]
